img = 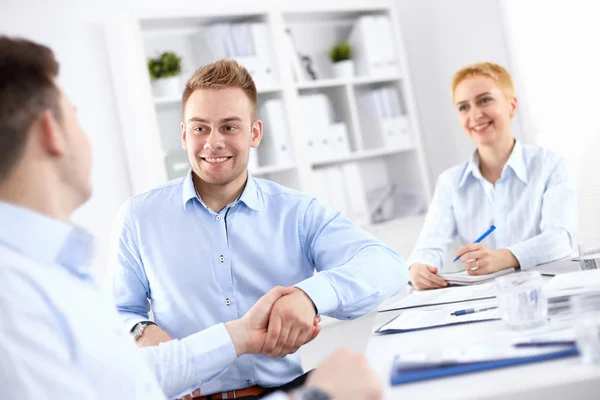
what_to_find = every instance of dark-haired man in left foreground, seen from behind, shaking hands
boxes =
[0,36,379,400]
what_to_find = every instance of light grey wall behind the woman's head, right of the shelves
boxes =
[396,0,527,189]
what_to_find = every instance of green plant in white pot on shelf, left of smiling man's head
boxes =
[148,51,181,96]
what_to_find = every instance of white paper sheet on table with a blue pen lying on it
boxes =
[377,304,501,333]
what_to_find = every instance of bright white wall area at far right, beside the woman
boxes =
[503,0,600,241]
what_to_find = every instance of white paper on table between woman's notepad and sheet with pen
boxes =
[379,283,496,312]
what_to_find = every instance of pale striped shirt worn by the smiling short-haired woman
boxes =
[408,141,577,269]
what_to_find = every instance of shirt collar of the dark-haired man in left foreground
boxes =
[0,201,94,278]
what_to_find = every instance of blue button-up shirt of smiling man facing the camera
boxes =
[109,171,408,394]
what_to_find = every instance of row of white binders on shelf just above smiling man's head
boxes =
[192,22,277,90]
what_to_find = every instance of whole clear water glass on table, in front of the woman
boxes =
[495,271,548,329]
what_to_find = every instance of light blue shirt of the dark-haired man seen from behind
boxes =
[0,202,248,400]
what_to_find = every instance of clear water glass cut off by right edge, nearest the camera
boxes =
[571,291,600,364]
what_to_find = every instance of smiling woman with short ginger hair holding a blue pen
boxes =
[409,62,577,289]
